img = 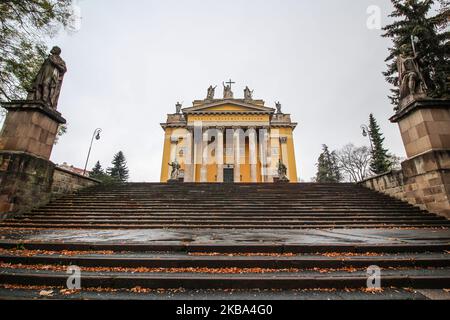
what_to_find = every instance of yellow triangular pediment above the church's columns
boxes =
[183,99,275,113]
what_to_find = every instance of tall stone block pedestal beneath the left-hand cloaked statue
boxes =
[0,101,66,214]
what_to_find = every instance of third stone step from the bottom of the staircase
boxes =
[0,251,450,269]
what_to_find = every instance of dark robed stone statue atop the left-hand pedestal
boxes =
[27,47,67,110]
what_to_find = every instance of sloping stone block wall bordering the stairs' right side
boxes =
[361,151,450,218]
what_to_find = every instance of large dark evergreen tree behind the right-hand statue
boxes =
[383,0,450,105]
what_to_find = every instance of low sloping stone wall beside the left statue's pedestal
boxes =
[51,167,100,195]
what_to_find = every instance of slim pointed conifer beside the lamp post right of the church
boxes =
[369,113,392,174]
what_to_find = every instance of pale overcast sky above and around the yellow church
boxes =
[51,0,405,182]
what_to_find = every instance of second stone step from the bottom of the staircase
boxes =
[0,268,450,289]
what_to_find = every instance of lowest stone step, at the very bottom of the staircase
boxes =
[0,286,436,302]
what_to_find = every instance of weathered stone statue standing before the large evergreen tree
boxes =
[397,45,427,100]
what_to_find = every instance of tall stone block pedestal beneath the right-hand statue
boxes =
[390,99,450,217]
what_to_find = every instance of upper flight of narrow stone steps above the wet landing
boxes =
[0,183,450,229]
